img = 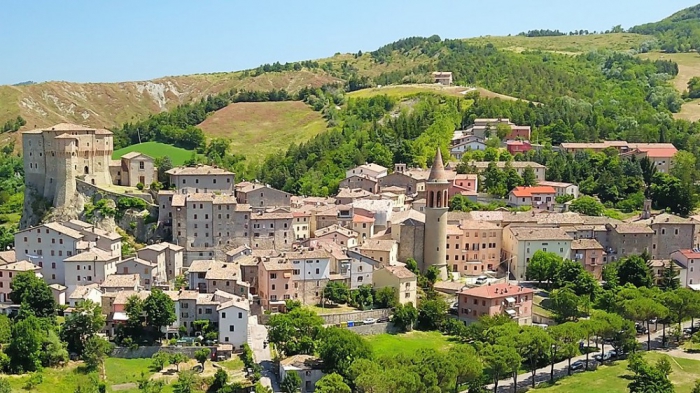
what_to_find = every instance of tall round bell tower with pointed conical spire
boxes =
[423,147,450,280]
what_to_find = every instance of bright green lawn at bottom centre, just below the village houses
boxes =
[367,331,452,356]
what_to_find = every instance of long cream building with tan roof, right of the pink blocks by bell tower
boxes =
[503,225,574,280]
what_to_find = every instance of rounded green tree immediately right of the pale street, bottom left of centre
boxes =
[268,308,324,356]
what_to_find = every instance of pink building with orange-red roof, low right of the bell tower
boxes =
[459,282,534,325]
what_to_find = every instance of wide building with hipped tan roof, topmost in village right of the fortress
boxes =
[165,165,235,194]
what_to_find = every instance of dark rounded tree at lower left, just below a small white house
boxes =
[61,300,105,356]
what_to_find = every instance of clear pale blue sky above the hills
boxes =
[0,0,699,84]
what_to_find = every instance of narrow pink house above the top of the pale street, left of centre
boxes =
[258,257,294,312]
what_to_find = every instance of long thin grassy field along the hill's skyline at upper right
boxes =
[466,33,649,53]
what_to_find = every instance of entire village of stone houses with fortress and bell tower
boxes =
[0,119,700,391]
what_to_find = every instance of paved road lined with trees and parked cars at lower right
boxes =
[476,321,690,393]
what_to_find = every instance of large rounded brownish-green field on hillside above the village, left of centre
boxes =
[197,101,326,161]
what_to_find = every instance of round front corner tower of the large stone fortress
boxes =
[51,134,78,206]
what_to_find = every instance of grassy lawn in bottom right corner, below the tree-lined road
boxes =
[537,352,700,393]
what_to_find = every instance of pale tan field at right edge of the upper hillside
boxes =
[639,52,700,121]
